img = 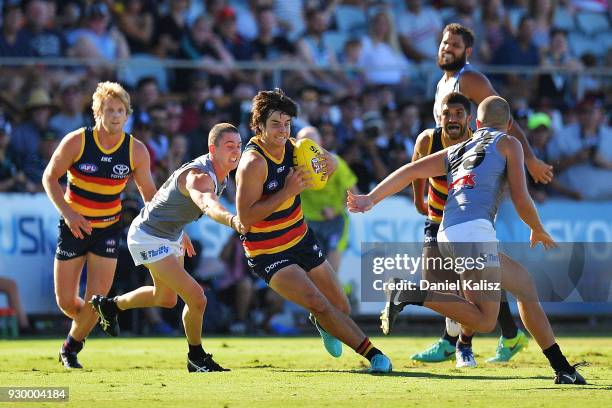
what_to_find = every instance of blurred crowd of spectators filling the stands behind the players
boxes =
[0,0,612,332]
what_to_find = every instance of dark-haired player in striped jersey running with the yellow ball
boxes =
[236,89,391,373]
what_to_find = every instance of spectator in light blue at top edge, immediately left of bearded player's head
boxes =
[396,0,444,63]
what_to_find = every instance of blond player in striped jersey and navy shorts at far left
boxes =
[42,82,172,368]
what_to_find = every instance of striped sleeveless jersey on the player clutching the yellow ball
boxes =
[241,136,308,258]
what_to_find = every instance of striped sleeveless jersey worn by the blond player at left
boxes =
[64,128,134,228]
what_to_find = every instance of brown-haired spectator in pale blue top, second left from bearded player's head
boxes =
[359,11,409,85]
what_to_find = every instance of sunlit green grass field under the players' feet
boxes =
[0,336,612,408]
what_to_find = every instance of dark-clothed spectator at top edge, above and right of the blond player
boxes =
[117,0,155,54]
